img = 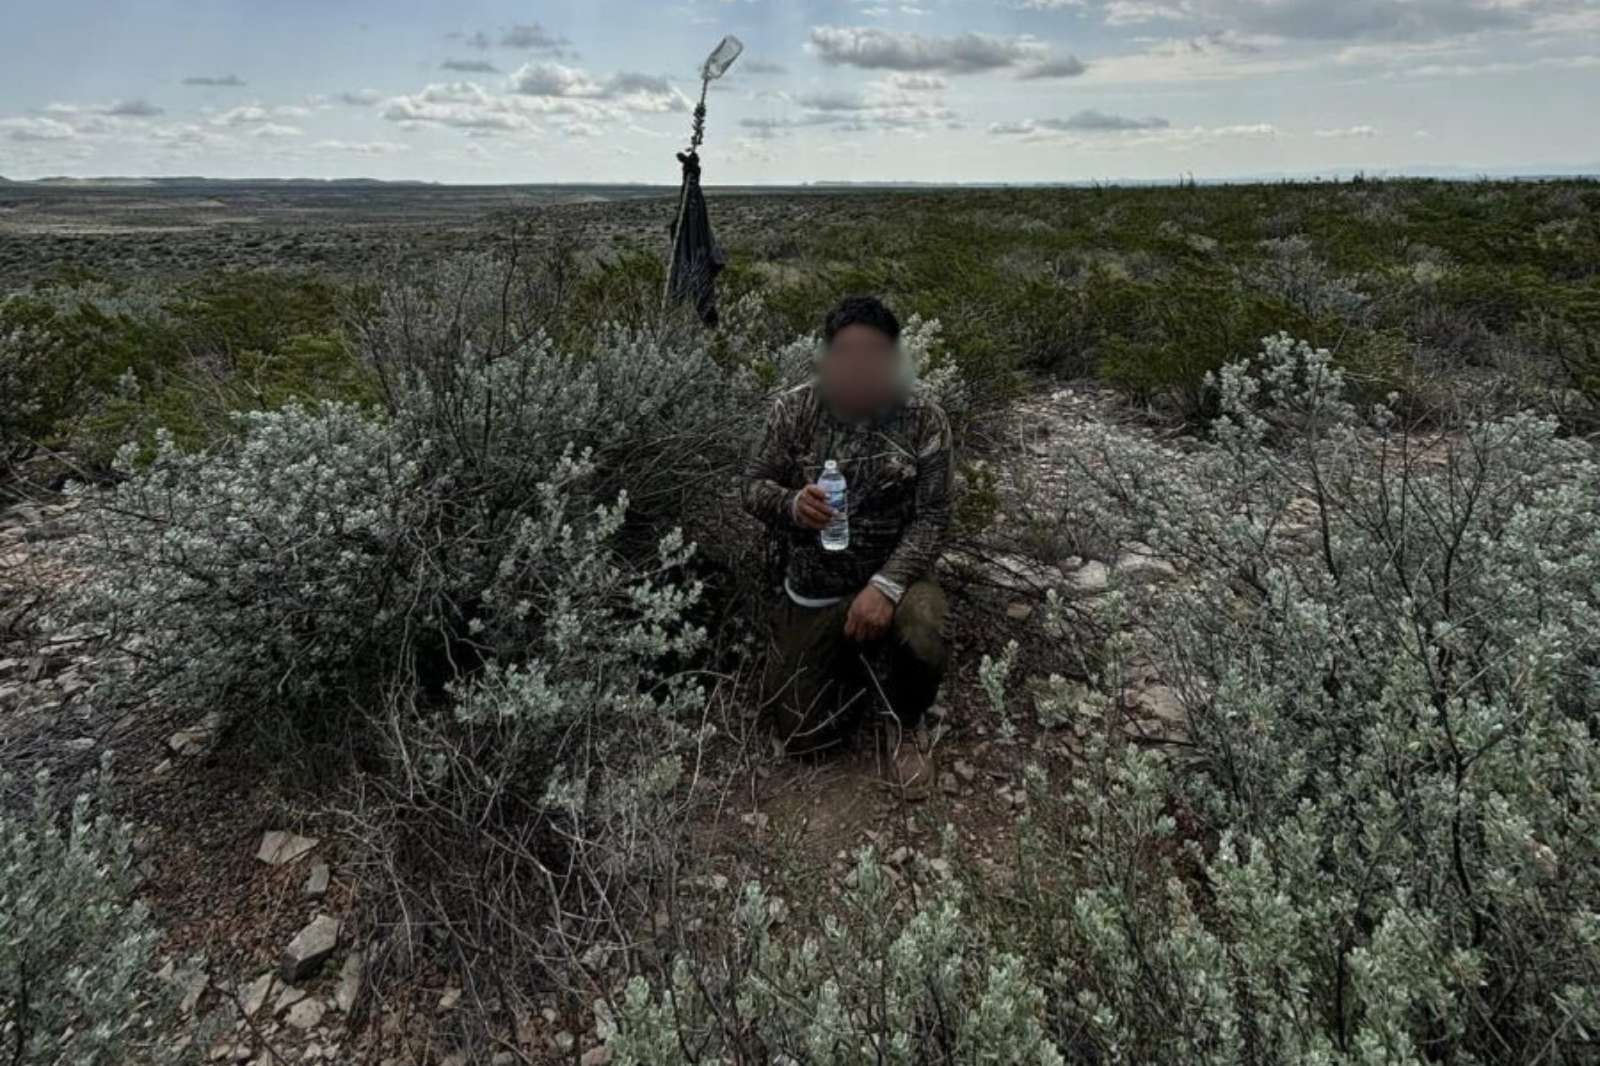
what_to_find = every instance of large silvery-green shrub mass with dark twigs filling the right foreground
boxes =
[1040,338,1600,1063]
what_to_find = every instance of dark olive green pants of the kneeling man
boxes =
[763,581,947,754]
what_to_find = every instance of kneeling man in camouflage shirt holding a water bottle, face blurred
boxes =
[742,298,952,792]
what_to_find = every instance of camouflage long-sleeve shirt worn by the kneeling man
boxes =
[742,383,952,603]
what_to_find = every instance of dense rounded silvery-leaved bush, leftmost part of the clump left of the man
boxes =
[58,403,428,733]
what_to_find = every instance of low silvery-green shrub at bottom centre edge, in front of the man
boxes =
[608,848,1064,1066]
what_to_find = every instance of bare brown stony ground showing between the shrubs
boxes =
[0,377,1182,1066]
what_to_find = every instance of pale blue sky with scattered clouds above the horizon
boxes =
[0,0,1600,184]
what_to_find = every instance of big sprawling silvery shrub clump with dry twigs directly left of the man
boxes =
[45,246,765,1039]
